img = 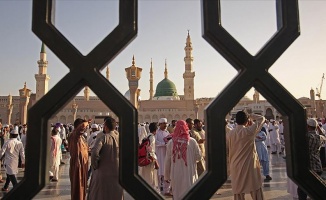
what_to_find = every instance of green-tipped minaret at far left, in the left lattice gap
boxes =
[35,43,50,101]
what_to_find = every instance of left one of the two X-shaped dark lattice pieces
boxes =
[4,0,166,199]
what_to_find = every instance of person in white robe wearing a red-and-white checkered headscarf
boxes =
[164,120,202,200]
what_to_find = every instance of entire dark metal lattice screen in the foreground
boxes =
[4,0,326,199]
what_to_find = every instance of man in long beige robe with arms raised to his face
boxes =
[228,111,265,200]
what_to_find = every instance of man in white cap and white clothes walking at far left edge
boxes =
[0,129,25,191]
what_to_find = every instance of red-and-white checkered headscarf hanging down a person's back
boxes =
[172,120,190,166]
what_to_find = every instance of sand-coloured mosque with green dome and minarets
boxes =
[0,32,325,124]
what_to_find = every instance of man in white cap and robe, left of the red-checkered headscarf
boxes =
[155,118,170,196]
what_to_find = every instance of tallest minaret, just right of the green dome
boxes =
[183,31,195,100]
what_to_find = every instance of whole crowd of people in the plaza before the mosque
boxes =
[0,111,326,200]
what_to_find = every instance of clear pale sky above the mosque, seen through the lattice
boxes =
[0,0,326,99]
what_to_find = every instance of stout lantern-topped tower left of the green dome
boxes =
[125,56,143,108]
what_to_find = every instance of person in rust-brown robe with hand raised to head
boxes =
[69,118,88,200]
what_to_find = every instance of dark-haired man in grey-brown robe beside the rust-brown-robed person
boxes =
[88,117,123,200]
